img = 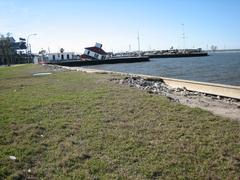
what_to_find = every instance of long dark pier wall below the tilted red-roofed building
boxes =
[48,56,149,67]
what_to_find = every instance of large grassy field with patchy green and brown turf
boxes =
[0,65,240,179]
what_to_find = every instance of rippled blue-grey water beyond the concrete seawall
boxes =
[85,52,240,86]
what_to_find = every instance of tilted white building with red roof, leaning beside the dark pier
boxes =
[82,43,108,60]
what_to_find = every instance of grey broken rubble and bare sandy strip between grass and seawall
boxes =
[111,76,240,120]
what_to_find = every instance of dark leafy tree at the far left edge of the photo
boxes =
[0,33,14,66]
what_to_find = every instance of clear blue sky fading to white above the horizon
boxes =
[0,0,240,53]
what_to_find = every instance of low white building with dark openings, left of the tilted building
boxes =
[47,52,76,61]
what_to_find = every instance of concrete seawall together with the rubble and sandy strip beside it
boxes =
[45,65,240,120]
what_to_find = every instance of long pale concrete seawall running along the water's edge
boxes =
[49,67,240,100]
